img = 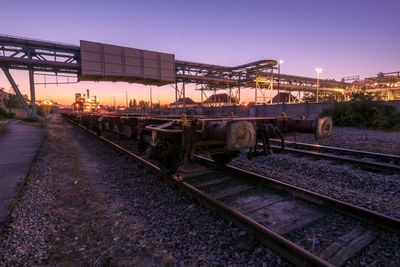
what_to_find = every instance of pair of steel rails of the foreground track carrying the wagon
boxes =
[64,116,400,266]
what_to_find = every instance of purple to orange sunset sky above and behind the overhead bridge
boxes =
[0,0,400,105]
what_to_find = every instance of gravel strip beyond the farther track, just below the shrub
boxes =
[294,127,400,155]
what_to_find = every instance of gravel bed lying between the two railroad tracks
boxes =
[232,154,400,218]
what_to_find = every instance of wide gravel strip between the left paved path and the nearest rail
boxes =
[0,116,289,266]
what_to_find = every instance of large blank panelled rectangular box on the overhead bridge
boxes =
[79,40,175,85]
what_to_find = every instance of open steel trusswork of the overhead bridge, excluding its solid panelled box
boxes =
[0,35,400,118]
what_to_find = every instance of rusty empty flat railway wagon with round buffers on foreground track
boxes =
[64,113,332,174]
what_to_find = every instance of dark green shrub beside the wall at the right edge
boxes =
[321,93,400,131]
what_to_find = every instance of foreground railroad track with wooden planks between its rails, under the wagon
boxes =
[64,118,400,266]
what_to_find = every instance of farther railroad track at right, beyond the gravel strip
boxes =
[270,139,400,172]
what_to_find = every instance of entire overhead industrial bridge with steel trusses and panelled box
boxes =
[0,36,400,117]
